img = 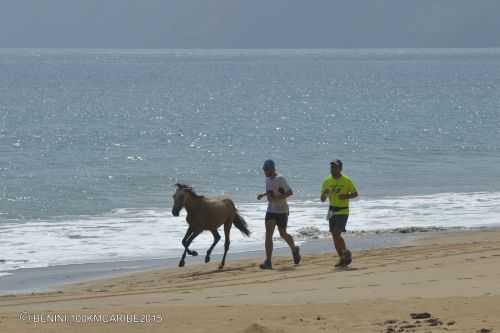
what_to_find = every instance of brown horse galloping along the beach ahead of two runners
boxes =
[172,184,250,269]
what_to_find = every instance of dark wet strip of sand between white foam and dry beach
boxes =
[0,227,488,296]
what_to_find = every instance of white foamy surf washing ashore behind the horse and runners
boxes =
[0,192,500,276]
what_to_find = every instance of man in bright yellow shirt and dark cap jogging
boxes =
[321,160,358,267]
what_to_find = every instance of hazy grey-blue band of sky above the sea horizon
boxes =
[0,0,500,48]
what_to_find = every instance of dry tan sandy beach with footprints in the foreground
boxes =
[0,230,500,333]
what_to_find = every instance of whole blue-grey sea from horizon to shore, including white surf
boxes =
[0,49,500,274]
